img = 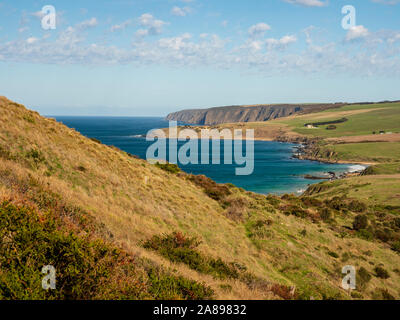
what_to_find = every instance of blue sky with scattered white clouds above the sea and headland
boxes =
[0,0,400,116]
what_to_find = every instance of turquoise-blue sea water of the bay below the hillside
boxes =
[55,116,351,194]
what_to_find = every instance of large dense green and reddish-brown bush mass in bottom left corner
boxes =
[0,201,214,300]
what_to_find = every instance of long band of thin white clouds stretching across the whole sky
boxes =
[0,20,400,76]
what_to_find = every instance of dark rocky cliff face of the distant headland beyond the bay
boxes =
[167,104,342,125]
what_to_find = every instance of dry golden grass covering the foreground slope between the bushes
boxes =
[0,97,400,299]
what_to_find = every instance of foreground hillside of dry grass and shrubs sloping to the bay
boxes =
[0,98,400,299]
